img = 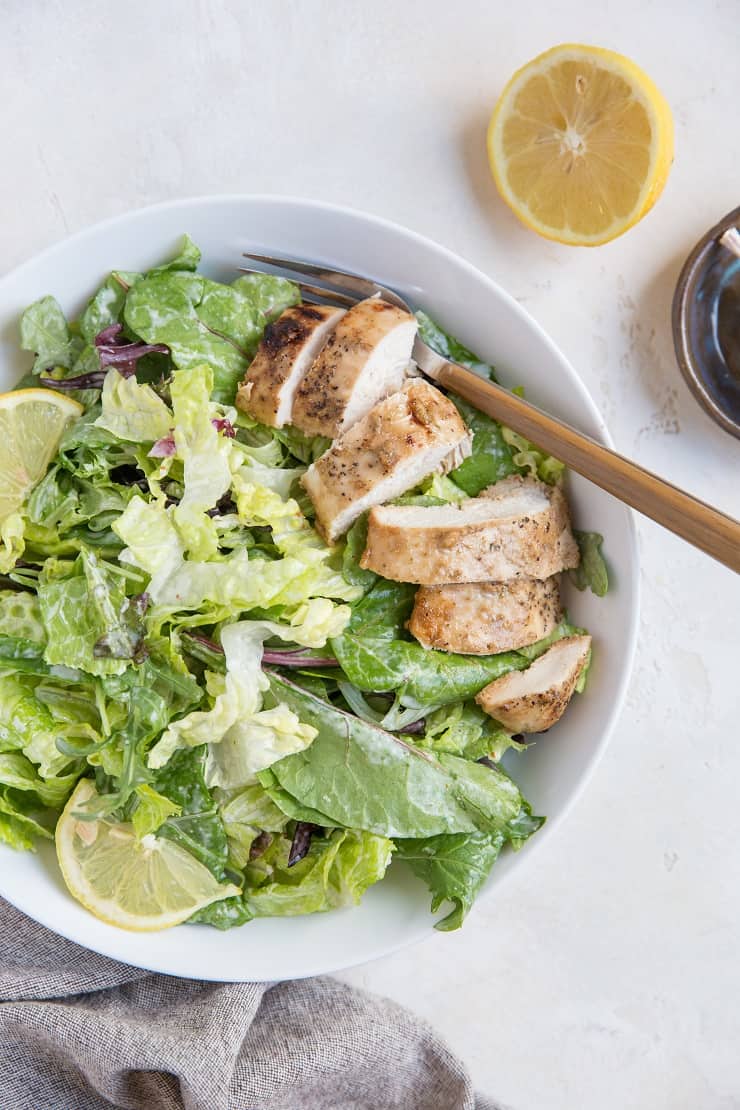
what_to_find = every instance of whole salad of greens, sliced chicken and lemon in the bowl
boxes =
[0,238,607,930]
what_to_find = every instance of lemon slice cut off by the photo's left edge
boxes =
[0,390,83,522]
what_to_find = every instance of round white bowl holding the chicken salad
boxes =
[0,196,638,981]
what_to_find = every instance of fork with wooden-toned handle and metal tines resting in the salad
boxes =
[240,252,740,573]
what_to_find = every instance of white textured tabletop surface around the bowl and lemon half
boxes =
[0,0,740,1110]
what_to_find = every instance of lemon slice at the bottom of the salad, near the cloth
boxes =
[57,779,240,932]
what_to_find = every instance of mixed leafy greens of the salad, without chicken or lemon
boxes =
[0,239,607,929]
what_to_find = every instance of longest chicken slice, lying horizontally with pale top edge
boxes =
[361,477,580,586]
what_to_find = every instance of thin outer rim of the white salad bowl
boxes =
[0,192,641,982]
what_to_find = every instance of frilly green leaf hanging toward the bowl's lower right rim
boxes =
[396,833,504,931]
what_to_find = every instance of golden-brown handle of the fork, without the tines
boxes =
[432,362,740,574]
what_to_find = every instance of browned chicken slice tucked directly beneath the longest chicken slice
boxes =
[407,577,562,655]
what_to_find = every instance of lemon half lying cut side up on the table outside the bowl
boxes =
[488,43,673,246]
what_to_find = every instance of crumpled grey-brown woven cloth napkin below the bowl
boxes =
[0,900,496,1110]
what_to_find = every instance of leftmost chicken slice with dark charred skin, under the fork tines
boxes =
[236,304,344,427]
